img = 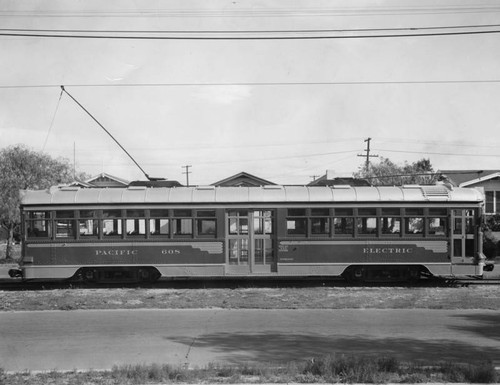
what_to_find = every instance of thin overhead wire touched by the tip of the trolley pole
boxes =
[0,79,500,89]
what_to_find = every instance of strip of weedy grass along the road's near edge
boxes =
[0,355,499,385]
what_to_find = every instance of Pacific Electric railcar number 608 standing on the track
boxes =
[14,185,485,282]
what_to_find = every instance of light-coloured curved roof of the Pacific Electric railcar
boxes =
[21,185,484,205]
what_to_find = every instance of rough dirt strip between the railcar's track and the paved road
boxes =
[0,285,500,311]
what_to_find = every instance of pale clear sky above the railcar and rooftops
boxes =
[0,0,500,185]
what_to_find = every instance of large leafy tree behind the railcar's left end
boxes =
[0,145,73,260]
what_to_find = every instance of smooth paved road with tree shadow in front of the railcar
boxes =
[0,309,500,371]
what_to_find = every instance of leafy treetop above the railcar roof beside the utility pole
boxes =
[354,157,436,186]
